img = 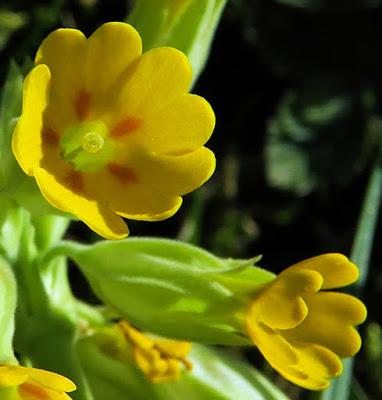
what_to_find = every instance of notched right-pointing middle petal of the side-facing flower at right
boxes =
[283,292,366,357]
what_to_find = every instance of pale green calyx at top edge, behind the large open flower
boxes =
[128,0,227,82]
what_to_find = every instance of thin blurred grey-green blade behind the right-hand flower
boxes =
[315,161,382,400]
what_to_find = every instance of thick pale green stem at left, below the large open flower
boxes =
[8,216,93,400]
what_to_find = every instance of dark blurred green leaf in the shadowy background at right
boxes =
[265,80,378,195]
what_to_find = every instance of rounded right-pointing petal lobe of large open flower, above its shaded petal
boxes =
[120,94,215,154]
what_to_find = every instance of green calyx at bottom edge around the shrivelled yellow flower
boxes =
[77,335,288,400]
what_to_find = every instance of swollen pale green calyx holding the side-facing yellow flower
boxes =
[59,238,273,344]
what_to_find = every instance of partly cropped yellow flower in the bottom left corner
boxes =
[0,365,76,400]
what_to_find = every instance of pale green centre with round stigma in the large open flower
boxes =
[60,121,115,172]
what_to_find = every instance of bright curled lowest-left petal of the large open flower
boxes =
[35,168,128,239]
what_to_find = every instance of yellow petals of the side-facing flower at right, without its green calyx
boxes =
[246,254,366,390]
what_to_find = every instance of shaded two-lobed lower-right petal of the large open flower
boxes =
[88,147,215,221]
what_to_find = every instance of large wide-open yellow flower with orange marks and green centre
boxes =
[12,22,215,239]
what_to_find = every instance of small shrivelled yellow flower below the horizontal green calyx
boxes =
[118,321,192,383]
